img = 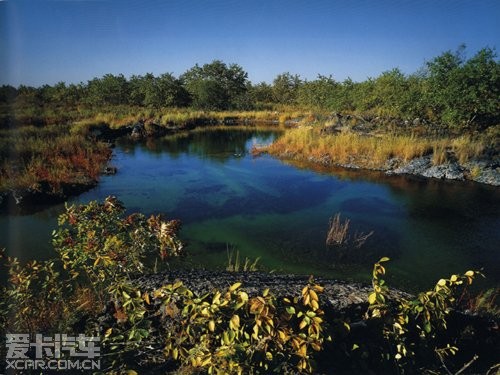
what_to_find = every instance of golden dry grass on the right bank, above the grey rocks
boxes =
[261,126,492,169]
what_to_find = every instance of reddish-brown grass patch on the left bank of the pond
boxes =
[0,125,111,193]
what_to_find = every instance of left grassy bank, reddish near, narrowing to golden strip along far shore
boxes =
[0,105,313,192]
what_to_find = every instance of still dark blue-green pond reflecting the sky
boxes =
[0,127,500,291]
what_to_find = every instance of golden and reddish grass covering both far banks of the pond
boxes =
[0,105,499,197]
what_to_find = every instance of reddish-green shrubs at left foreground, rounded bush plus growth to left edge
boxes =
[2,197,182,332]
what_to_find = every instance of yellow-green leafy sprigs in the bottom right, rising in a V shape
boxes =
[367,257,483,372]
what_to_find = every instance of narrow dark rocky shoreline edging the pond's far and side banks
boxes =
[0,120,500,213]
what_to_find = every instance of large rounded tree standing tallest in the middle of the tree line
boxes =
[180,60,248,110]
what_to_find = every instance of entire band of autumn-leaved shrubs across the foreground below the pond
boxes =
[0,197,497,374]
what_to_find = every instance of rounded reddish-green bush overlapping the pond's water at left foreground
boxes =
[53,197,182,288]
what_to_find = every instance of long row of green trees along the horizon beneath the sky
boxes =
[0,46,500,128]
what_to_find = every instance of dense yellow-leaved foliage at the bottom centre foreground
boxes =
[153,281,326,374]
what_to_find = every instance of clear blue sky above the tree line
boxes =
[0,0,500,86]
